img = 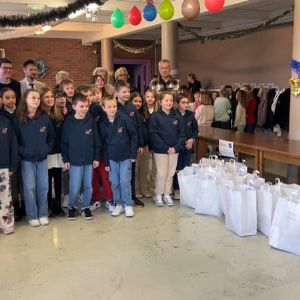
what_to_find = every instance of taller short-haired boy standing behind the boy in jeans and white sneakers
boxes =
[115,80,144,207]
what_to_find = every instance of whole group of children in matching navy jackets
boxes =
[0,79,198,237]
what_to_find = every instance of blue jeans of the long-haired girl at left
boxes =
[22,159,48,220]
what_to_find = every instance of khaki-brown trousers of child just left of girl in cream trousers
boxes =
[135,146,150,195]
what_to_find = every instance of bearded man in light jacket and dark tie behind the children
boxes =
[20,59,46,95]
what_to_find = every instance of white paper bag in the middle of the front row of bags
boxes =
[225,185,257,236]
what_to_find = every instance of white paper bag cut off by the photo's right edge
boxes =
[269,193,300,255]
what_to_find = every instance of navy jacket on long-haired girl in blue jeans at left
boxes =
[14,111,55,162]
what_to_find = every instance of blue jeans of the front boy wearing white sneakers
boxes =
[109,159,133,206]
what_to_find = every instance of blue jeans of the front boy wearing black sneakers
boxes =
[68,165,93,209]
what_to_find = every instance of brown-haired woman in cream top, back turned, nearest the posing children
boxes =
[195,92,214,130]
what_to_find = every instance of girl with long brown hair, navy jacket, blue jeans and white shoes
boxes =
[15,89,55,226]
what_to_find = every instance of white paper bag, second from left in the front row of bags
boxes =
[195,174,223,217]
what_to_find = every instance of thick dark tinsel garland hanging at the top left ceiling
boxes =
[0,0,107,27]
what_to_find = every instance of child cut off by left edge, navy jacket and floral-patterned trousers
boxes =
[0,115,18,234]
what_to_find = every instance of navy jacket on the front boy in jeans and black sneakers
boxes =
[61,113,101,166]
